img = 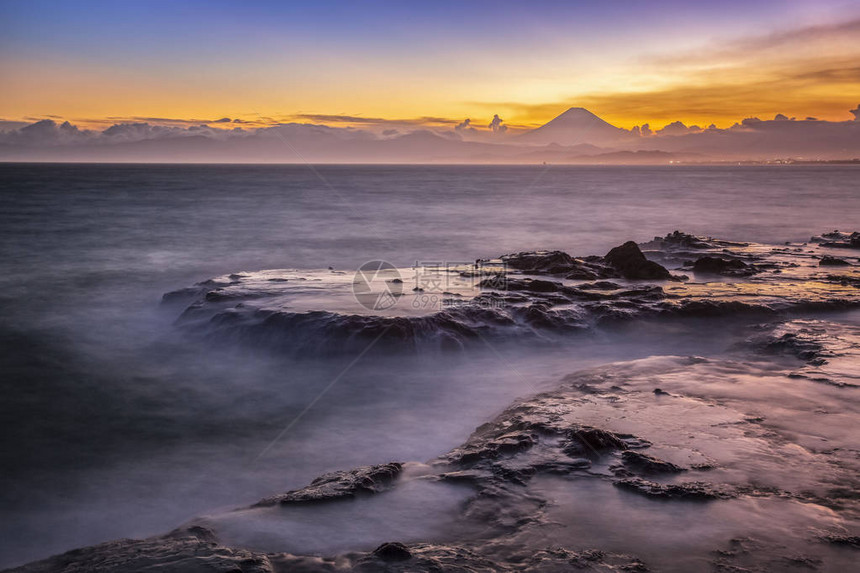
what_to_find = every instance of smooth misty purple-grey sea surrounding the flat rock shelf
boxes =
[0,165,860,566]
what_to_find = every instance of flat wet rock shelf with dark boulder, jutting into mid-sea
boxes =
[164,231,860,355]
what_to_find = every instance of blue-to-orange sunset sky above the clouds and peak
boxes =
[0,0,860,128]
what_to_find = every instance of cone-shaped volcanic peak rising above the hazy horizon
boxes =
[517,107,632,145]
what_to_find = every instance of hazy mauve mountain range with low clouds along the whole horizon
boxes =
[0,107,860,164]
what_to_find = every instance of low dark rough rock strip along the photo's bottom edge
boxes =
[9,527,648,573]
